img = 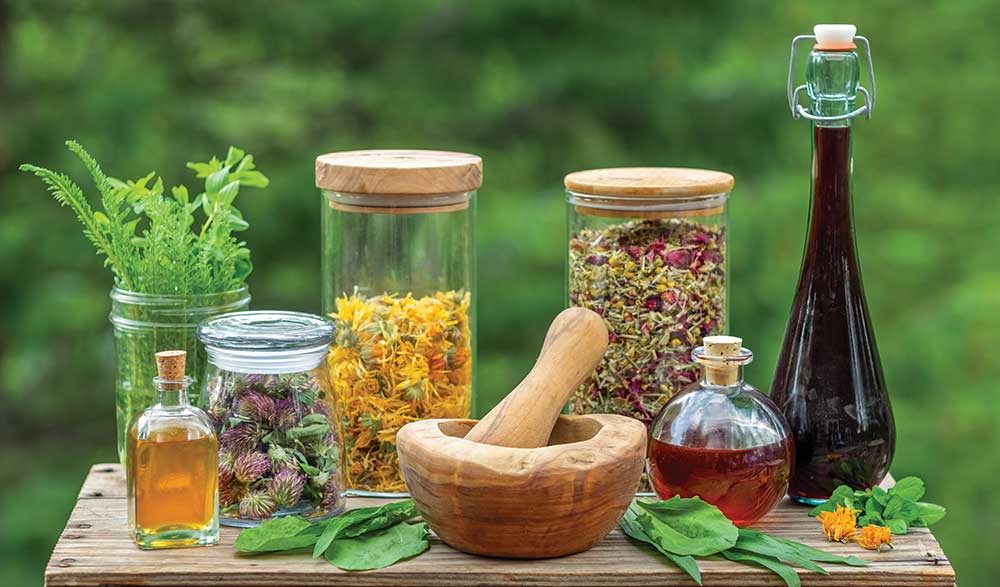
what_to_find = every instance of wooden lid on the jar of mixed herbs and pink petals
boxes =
[564,167,734,218]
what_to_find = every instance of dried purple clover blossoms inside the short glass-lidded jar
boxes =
[207,372,340,520]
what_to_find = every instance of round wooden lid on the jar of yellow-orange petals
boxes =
[316,149,483,196]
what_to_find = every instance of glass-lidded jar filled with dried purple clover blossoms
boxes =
[198,311,343,526]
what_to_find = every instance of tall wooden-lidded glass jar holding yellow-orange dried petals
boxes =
[316,150,482,495]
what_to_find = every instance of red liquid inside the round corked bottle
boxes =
[649,438,795,526]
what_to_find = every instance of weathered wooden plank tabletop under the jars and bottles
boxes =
[45,465,955,587]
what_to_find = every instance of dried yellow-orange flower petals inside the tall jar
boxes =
[328,291,472,492]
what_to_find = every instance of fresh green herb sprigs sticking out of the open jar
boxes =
[20,141,268,294]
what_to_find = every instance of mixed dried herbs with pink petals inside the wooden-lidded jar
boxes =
[569,219,726,425]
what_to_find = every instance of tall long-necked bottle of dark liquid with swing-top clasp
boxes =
[771,27,895,504]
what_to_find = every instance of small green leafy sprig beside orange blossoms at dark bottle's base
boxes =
[809,477,948,534]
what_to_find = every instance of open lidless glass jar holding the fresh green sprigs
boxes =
[110,287,250,465]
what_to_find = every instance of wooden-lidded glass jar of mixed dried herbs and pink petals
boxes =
[565,167,733,425]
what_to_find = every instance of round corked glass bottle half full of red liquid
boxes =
[647,336,795,526]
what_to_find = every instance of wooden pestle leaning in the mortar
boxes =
[465,308,608,448]
